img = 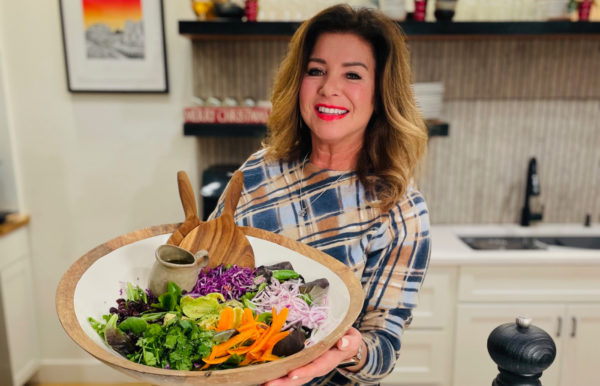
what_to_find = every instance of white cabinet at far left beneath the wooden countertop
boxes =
[0,227,40,386]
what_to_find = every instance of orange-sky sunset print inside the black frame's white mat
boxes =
[81,0,144,60]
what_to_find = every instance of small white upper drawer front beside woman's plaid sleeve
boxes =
[410,267,457,331]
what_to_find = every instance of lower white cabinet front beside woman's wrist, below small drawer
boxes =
[381,329,452,386]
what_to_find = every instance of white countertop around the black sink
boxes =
[431,224,600,266]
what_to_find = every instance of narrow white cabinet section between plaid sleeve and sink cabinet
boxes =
[381,267,457,386]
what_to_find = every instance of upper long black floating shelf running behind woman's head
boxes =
[179,20,600,39]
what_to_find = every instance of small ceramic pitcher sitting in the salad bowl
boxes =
[148,244,208,296]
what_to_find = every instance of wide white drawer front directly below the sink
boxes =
[458,266,600,302]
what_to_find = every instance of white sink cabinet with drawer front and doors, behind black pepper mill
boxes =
[453,266,600,386]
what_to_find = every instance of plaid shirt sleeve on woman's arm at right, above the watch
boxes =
[338,190,430,384]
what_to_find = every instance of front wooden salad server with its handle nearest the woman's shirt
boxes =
[179,170,254,268]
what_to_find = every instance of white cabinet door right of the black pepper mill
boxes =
[561,304,600,386]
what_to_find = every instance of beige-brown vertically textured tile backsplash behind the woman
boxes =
[193,37,600,224]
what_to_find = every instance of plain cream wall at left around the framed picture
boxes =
[0,0,198,383]
